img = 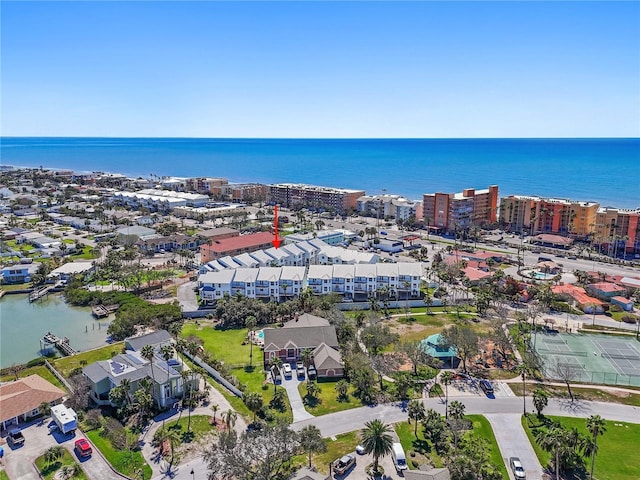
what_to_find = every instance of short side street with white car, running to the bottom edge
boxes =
[486,413,542,480]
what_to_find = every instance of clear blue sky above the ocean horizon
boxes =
[0,1,640,138]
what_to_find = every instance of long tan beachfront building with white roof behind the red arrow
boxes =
[268,183,365,213]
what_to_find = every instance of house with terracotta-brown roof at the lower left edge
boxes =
[0,375,66,430]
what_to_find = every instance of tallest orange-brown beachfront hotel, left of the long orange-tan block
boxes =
[422,185,498,231]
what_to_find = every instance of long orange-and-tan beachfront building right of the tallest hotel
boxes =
[500,195,599,237]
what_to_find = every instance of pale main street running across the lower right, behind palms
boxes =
[292,395,640,437]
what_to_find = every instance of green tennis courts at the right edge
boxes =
[532,332,640,387]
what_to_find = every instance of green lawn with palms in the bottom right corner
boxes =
[522,416,640,480]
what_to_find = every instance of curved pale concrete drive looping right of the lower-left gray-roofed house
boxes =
[140,380,247,478]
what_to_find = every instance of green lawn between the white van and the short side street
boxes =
[394,415,509,479]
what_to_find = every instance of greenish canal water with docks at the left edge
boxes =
[0,295,109,368]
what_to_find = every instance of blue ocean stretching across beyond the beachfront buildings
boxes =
[0,137,640,208]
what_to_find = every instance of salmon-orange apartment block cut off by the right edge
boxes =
[594,207,640,255]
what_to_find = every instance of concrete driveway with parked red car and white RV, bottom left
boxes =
[5,420,118,480]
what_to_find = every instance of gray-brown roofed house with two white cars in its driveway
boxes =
[263,313,344,378]
